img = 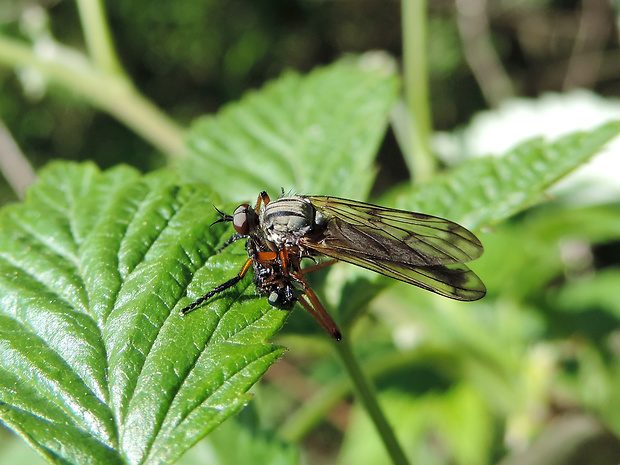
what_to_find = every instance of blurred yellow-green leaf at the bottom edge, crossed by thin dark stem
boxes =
[338,384,495,465]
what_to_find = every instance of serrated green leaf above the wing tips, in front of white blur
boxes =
[396,122,620,228]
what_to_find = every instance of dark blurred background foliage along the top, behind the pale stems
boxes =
[0,0,620,183]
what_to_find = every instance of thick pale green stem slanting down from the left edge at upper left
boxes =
[0,35,185,156]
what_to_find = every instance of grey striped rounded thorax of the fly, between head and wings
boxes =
[259,196,323,247]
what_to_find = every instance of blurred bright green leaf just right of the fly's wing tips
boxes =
[475,202,620,300]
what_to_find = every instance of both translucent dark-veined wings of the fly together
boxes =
[303,197,486,301]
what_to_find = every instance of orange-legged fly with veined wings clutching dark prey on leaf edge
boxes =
[181,192,486,340]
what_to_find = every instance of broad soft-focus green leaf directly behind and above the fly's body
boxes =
[180,57,398,201]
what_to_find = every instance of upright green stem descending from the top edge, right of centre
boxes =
[401,0,436,183]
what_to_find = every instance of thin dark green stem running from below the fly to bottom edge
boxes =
[334,339,409,465]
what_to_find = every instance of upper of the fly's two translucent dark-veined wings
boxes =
[307,196,483,264]
